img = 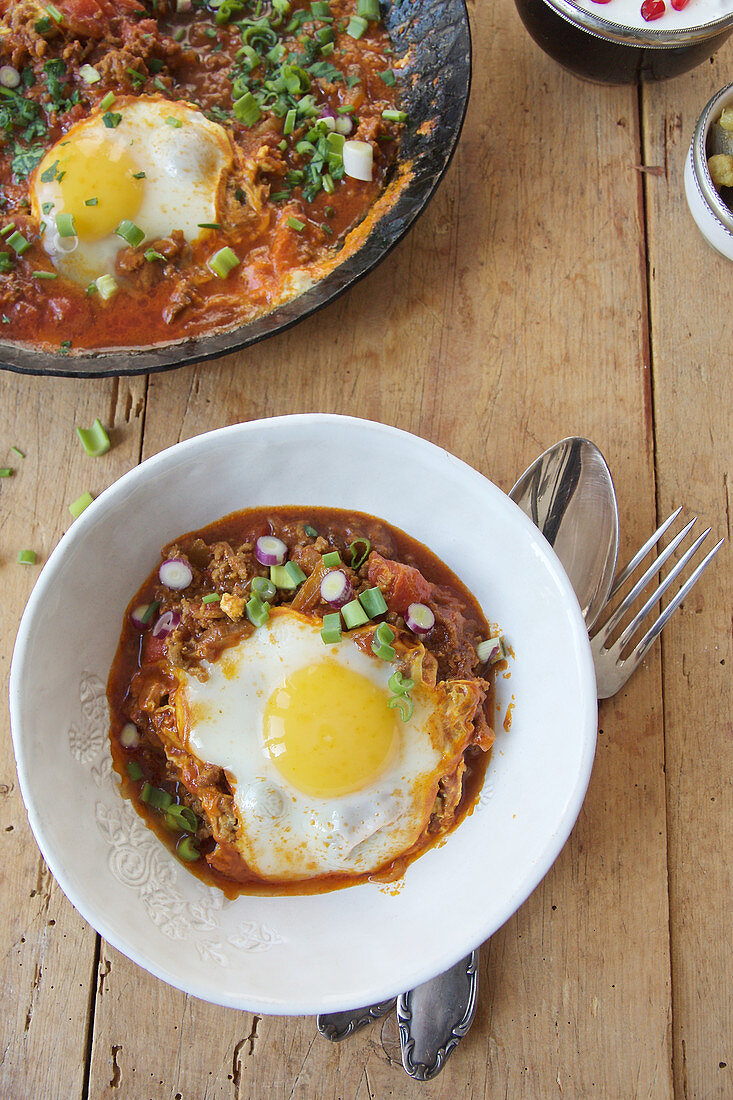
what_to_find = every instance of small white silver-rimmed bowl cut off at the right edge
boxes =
[685,84,733,260]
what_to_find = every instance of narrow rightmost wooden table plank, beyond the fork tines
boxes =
[645,58,733,1100]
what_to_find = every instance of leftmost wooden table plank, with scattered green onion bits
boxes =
[0,373,144,1100]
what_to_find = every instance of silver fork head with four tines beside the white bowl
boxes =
[591,507,725,699]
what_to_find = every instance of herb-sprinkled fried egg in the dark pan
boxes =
[31,96,232,286]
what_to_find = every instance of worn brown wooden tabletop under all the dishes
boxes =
[0,0,733,1100]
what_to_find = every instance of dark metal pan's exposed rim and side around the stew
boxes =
[0,0,471,377]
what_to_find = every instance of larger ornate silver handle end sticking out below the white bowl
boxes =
[397,949,479,1081]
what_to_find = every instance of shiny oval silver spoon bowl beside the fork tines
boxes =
[508,436,619,630]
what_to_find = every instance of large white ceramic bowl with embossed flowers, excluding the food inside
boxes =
[10,415,597,1014]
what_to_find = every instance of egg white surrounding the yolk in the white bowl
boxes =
[176,608,442,881]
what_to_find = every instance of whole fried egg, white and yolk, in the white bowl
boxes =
[175,607,468,881]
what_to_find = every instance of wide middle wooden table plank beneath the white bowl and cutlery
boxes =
[85,0,671,1100]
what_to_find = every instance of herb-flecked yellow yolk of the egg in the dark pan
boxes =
[39,138,144,241]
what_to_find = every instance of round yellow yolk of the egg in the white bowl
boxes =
[263,660,398,799]
